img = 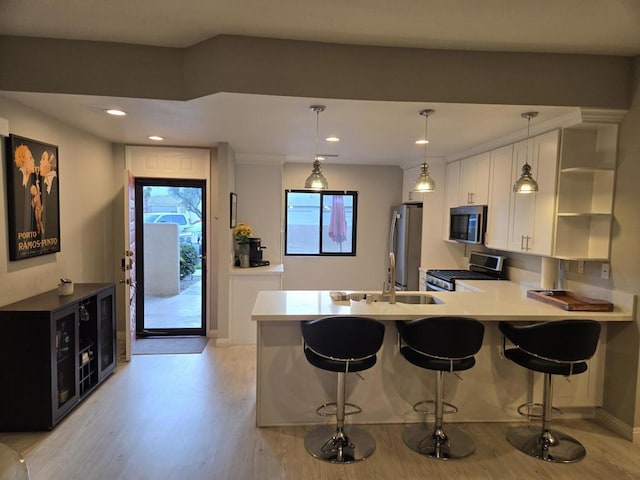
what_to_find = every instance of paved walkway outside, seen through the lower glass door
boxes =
[144,270,202,328]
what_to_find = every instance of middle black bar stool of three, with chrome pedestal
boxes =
[396,317,484,460]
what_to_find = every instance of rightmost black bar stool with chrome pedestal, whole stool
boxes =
[499,320,600,463]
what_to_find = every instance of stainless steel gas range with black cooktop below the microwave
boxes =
[426,252,507,292]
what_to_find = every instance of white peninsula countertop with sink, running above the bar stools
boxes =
[251,282,635,322]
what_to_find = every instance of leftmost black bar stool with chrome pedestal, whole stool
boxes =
[301,316,384,463]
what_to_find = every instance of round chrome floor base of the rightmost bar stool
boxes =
[507,426,587,463]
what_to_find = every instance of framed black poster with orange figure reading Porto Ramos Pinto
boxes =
[6,135,60,260]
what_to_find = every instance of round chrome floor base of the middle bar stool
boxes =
[402,423,476,460]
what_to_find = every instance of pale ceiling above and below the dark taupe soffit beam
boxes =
[0,0,640,167]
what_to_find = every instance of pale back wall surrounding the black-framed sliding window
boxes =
[283,163,402,290]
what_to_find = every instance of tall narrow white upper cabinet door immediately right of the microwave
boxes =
[485,145,513,250]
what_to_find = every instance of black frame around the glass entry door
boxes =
[135,177,208,338]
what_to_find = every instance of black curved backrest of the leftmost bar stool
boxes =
[300,316,384,361]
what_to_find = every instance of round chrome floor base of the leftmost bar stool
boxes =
[304,425,376,463]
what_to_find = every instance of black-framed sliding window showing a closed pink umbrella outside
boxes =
[284,190,358,256]
